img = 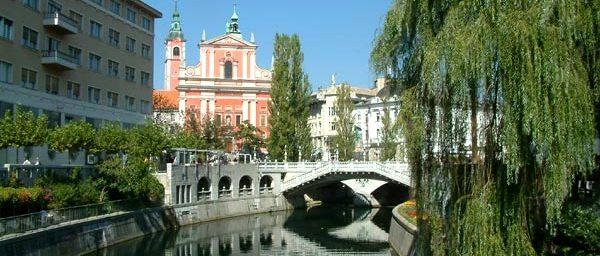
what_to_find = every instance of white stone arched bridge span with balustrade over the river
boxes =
[258,161,410,192]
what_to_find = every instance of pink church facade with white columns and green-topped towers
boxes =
[155,4,271,140]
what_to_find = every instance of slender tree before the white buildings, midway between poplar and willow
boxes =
[333,84,356,161]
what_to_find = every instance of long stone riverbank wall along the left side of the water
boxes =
[0,195,293,256]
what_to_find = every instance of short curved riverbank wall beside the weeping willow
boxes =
[388,205,417,256]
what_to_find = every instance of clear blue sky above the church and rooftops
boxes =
[145,0,392,90]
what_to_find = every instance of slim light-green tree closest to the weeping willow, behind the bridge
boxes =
[381,99,398,161]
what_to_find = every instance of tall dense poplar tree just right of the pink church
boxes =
[267,34,312,160]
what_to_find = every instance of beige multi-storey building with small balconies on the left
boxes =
[0,0,162,127]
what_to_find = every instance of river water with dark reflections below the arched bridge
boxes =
[90,207,391,256]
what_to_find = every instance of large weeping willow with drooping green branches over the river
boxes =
[371,0,600,255]
